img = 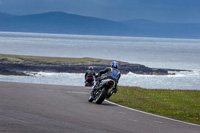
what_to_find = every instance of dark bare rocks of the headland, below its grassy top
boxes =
[0,58,175,76]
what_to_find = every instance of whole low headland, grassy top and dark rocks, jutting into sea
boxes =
[0,54,168,75]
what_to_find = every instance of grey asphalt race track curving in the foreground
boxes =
[0,82,200,133]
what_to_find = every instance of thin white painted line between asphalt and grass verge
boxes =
[105,100,200,127]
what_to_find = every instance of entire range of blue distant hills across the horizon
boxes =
[0,12,200,38]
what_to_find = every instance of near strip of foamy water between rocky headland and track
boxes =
[0,71,200,90]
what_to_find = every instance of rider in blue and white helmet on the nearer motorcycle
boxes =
[91,61,121,98]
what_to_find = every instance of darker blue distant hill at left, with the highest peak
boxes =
[0,12,134,35]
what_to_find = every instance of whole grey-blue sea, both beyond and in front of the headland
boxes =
[0,32,200,90]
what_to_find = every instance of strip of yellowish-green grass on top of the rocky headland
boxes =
[0,54,111,65]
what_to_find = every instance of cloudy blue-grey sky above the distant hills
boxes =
[0,0,200,22]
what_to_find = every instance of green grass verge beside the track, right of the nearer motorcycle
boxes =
[110,87,200,124]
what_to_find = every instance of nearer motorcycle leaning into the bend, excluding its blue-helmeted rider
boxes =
[88,79,115,104]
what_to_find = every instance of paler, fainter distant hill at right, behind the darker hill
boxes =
[120,19,200,38]
